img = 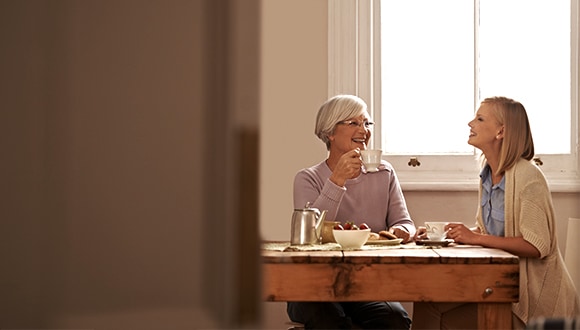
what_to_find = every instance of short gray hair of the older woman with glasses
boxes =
[314,95,367,150]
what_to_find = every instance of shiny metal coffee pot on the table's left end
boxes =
[290,203,326,245]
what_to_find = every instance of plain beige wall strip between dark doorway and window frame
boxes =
[260,0,328,239]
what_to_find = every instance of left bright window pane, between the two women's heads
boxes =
[381,0,475,154]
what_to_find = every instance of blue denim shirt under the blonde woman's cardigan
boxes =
[479,165,505,236]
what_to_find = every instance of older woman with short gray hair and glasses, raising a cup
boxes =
[287,95,415,329]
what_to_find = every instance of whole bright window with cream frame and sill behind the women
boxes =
[329,0,580,191]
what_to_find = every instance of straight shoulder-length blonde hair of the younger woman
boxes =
[481,96,534,175]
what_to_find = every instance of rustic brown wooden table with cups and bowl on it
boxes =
[262,243,519,329]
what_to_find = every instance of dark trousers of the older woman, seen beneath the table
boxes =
[286,301,411,329]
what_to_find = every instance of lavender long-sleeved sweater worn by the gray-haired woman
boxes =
[294,161,416,237]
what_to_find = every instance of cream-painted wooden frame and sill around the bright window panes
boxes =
[328,0,580,192]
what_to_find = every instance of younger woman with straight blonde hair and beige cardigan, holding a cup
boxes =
[413,97,580,329]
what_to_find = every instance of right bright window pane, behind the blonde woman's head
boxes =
[478,0,571,154]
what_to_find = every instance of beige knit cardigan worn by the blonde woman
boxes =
[477,159,580,324]
